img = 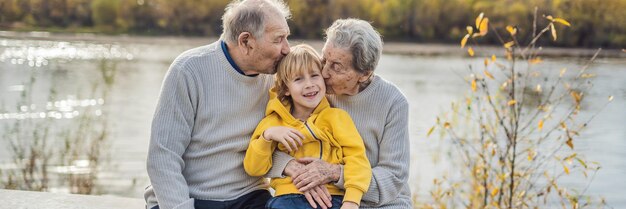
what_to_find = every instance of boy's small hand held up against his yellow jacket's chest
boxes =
[263,126,304,152]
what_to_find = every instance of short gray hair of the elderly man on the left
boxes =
[221,0,291,44]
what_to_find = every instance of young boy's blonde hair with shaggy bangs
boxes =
[274,44,322,102]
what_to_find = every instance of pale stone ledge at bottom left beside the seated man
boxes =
[0,189,146,209]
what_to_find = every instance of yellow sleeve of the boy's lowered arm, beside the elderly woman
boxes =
[332,109,372,204]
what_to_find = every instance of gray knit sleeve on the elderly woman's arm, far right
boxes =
[363,97,410,206]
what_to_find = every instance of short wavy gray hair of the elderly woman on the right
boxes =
[326,18,383,73]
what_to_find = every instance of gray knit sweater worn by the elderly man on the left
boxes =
[145,41,273,209]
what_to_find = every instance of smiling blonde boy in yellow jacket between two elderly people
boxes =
[244,45,372,209]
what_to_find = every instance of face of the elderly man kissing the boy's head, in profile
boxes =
[251,15,289,74]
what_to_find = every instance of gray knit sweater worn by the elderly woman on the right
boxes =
[268,75,412,209]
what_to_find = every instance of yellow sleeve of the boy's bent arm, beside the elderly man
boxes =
[243,116,277,176]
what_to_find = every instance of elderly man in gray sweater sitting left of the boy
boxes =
[145,0,291,209]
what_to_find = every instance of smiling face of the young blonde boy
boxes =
[285,67,326,112]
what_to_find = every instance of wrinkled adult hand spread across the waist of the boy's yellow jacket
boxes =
[291,157,341,192]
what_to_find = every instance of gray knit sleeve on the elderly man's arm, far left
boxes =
[147,65,198,209]
